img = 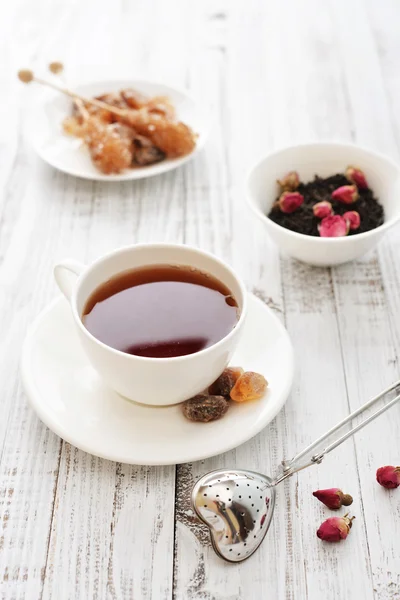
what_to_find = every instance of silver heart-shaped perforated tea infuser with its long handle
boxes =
[192,381,400,563]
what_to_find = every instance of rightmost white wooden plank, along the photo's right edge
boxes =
[338,2,400,598]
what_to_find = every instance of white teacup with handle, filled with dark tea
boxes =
[54,244,247,406]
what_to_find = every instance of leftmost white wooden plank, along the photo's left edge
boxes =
[0,2,75,599]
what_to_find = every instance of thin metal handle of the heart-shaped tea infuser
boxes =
[273,381,400,485]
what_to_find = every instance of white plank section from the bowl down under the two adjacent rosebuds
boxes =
[282,260,373,598]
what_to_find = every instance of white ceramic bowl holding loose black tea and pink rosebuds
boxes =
[247,142,400,266]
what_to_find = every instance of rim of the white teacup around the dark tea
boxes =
[70,242,247,364]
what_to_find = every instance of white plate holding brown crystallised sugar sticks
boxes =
[30,80,208,181]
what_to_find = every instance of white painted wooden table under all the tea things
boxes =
[0,0,400,600]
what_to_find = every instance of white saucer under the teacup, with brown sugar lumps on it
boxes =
[21,294,293,465]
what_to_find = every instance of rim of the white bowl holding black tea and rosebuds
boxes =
[246,141,400,244]
